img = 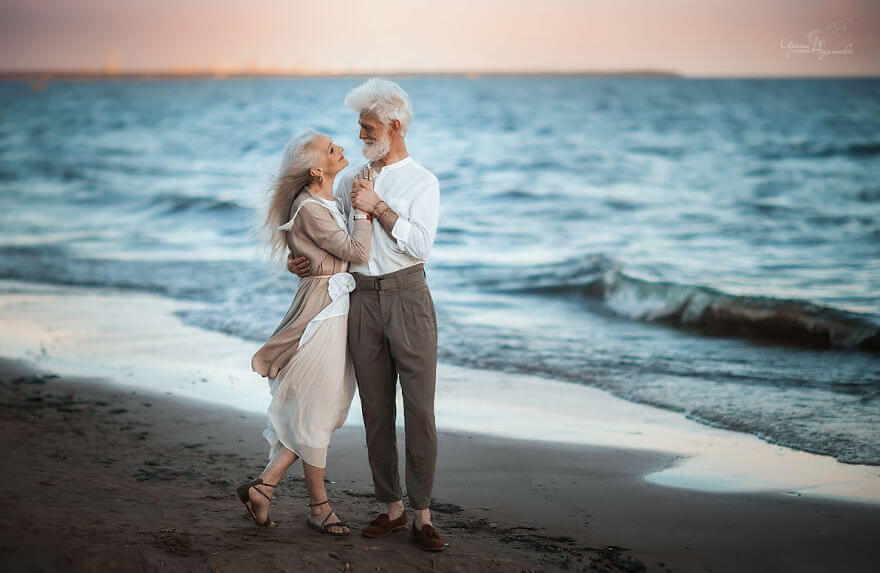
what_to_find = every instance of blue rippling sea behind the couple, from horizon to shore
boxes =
[0,76,880,465]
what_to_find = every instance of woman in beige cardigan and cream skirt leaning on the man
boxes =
[237,130,372,535]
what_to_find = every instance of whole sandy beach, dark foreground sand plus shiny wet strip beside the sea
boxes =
[0,283,880,572]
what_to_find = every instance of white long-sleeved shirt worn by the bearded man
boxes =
[334,156,440,276]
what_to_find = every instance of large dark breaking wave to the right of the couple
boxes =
[492,255,880,352]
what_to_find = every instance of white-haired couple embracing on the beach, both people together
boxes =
[237,78,445,551]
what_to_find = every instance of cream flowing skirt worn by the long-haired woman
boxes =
[263,314,357,468]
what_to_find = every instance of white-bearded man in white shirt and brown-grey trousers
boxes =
[288,78,445,551]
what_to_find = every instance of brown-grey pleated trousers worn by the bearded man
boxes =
[348,264,437,509]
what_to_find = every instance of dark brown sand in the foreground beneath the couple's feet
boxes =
[0,359,880,571]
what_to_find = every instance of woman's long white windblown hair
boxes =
[262,129,321,265]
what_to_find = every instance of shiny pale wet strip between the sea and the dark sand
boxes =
[0,281,880,506]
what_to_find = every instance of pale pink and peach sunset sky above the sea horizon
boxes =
[0,0,880,77]
